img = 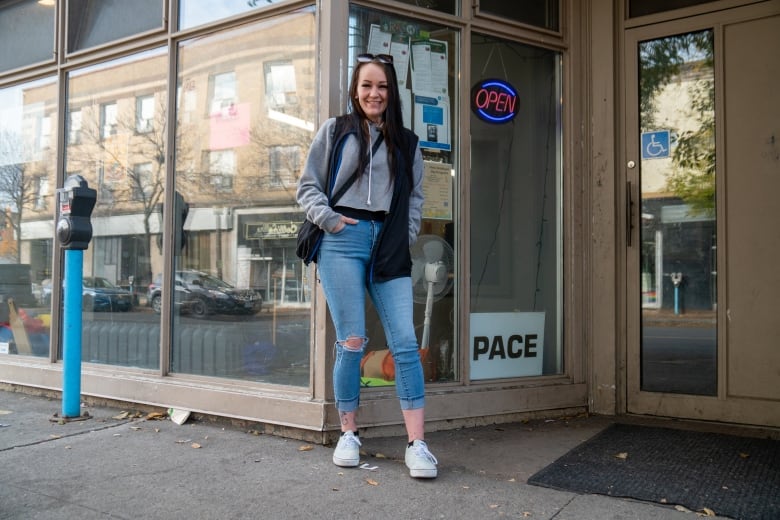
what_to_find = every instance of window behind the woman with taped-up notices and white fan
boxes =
[348,7,460,386]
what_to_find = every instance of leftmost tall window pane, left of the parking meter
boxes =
[0,78,57,356]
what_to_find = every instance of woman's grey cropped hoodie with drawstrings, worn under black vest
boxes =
[297,118,423,245]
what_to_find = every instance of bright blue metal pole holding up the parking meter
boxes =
[62,249,84,418]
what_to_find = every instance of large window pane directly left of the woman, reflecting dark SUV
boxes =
[171,9,317,386]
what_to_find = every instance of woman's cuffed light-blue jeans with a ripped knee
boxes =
[317,220,425,412]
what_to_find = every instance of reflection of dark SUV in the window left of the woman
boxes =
[147,270,263,317]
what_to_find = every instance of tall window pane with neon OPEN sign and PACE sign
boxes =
[469,34,562,380]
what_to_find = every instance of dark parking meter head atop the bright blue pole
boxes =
[57,175,97,250]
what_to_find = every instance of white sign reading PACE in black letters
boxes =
[470,312,545,379]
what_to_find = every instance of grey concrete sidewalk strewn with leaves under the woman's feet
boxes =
[0,390,724,520]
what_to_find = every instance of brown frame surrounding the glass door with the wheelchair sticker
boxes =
[617,1,780,426]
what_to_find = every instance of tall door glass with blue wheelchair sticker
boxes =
[626,23,718,414]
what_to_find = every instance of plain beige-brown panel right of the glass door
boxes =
[724,16,780,400]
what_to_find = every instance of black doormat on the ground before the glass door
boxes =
[528,424,780,520]
